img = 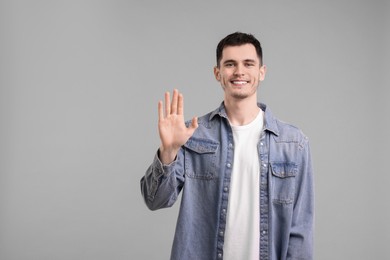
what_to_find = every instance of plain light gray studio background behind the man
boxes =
[0,0,390,260]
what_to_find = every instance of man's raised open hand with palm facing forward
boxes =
[158,89,198,164]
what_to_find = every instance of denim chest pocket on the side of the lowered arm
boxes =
[270,162,298,204]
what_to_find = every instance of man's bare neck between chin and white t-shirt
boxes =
[224,96,260,126]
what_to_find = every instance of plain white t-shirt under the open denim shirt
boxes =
[223,110,264,260]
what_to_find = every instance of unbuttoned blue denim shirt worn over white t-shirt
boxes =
[141,103,314,260]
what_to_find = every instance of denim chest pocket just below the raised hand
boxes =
[184,138,219,180]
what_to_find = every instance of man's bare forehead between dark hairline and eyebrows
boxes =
[222,44,259,62]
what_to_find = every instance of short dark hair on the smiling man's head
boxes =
[217,32,263,67]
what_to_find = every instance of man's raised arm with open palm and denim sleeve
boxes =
[141,89,198,210]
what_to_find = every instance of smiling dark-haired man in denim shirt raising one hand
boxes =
[141,32,314,260]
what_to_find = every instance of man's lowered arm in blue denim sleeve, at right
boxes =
[287,137,314,260]
